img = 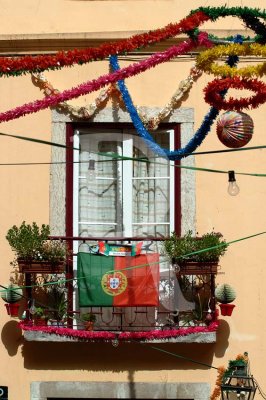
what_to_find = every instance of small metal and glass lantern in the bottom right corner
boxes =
[221,360,257,400]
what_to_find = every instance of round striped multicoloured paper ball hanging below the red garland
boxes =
[216,111,254,148]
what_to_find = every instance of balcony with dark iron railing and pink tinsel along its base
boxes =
[9,237,218,346]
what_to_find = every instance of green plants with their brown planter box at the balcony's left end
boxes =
[6,221,68,273]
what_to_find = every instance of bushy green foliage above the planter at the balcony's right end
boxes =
[163,231,228,263]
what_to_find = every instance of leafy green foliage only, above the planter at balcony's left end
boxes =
[6,221,69,264]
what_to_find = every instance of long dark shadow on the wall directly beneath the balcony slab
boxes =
[22,342,218,372]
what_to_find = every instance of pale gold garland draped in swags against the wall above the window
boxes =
[32,67,202,130]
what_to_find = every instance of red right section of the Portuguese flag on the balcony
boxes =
[113,253,159,307]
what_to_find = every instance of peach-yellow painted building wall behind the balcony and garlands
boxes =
[0,0,266,400]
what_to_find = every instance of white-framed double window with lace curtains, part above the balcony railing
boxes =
[73,128,179,238]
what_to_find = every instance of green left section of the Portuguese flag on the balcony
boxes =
[78,253,115,307]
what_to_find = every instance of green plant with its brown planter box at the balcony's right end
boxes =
[163,231,228,275]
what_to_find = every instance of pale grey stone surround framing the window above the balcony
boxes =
[49,107,196,236]
